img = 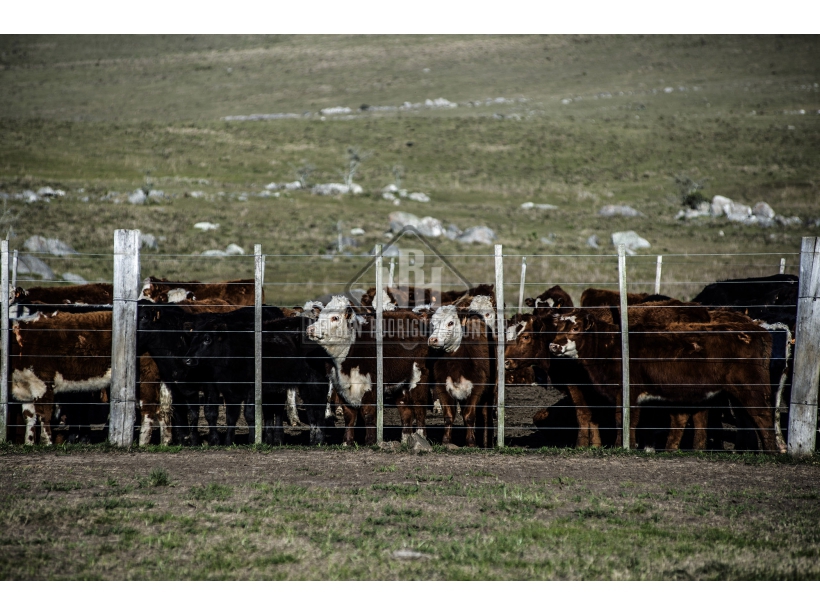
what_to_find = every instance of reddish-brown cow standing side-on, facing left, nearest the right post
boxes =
[550,306,779,452]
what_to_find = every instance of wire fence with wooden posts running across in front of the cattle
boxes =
[0,231,820,454]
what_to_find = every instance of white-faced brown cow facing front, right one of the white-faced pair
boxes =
[427,305,495,448]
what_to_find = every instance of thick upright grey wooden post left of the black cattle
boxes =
[108,229,140,446]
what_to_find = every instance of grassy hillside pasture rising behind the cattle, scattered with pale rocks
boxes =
[0,36,820,304]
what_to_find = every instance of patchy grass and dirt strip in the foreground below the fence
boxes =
[0,446,820,580]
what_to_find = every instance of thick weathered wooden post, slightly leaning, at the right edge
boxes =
[788,237,820,456]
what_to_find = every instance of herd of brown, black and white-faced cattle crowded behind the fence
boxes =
[7,274,798,452]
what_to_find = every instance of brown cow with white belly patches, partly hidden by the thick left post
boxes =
[9,312,169,444]
